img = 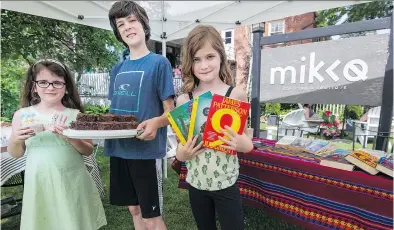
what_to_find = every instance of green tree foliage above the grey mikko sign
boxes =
[316,1,393,27]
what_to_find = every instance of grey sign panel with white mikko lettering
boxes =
[260,34,389,105]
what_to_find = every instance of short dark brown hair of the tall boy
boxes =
[108,1,150,47]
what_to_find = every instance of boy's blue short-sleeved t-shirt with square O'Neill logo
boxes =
[104,53,175,159]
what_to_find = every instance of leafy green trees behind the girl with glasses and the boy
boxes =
[1,10,124,121]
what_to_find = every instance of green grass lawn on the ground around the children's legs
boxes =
[1,150,301,230]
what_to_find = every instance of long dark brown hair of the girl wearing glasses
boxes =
[20,60,85,112]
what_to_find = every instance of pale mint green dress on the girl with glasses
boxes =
[20,107,107,230]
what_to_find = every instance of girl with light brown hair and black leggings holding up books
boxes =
[176,25,253,230]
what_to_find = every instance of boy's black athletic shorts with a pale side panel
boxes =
[109,157,163,219]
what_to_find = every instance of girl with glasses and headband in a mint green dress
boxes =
[8,60,107,230]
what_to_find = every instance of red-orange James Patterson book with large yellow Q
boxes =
[203,94,250,155]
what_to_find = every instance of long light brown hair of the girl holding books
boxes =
[182,25,233,93]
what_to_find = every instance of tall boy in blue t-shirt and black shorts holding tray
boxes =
[104,1,175,229]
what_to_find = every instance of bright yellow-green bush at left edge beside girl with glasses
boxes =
[1,58,27,121]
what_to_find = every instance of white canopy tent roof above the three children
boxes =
[1,1,368,56]
